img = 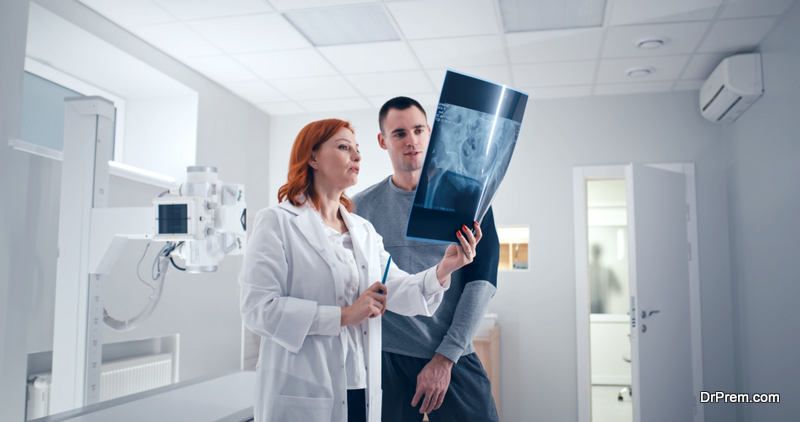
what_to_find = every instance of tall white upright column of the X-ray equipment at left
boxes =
[50,97,114,414]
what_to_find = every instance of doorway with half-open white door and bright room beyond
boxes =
[573,163,704,422]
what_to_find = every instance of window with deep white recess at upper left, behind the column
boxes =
[16,3,198,183]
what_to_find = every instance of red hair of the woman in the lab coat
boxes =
[278,119,355,212]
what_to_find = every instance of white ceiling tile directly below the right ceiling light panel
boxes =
[506,28,603,63]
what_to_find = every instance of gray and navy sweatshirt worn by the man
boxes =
[353,176,500,362]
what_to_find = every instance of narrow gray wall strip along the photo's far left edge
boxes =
[0,0,32,421]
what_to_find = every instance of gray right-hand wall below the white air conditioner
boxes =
[724,4,800,421]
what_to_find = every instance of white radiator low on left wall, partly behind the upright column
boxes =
[26,353,172,420]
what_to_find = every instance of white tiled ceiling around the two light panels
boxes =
[73,0,798,114]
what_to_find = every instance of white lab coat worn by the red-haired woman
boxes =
[239,201,449,422]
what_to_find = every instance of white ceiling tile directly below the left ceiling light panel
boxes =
[317,41,420,73]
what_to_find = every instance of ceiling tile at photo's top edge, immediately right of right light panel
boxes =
[608,0,722,25]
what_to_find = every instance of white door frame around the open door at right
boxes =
[572,163,705,422]
